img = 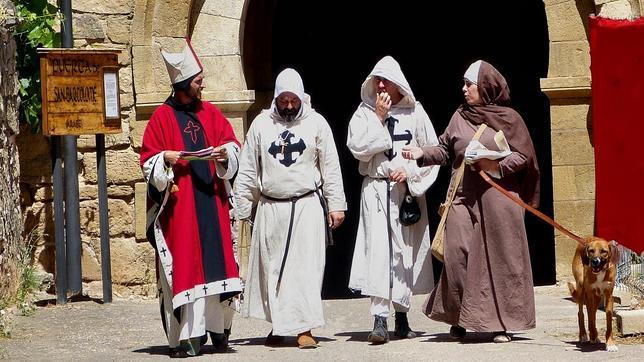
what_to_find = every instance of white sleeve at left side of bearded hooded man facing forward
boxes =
[233,122,260,220]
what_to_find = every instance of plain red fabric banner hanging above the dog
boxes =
[590,17,644,253]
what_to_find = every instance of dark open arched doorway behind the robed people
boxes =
[242,0,555,297]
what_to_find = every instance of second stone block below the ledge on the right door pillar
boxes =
[552,129,595,166]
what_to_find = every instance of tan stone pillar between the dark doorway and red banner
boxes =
[541,0,642,280]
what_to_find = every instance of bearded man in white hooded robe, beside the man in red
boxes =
[235,69,347,348]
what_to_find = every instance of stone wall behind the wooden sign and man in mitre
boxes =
[18,0,254,297]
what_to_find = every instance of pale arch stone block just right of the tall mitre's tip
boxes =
[192,14,240,58]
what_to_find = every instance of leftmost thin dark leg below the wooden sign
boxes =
[51,136,67,304]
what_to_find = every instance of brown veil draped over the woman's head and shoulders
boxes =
[458,61,539,207]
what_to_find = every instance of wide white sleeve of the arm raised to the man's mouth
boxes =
[347,106,393,162]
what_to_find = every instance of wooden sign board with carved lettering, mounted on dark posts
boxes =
[38,49,121,303]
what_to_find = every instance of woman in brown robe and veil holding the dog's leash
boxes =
[403,61,539,342]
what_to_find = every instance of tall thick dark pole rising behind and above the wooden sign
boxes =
[60,0,83,294]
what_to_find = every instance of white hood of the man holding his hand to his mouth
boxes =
[360,55,416,107]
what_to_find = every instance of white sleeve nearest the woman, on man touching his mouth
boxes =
[405,103,440,196]
